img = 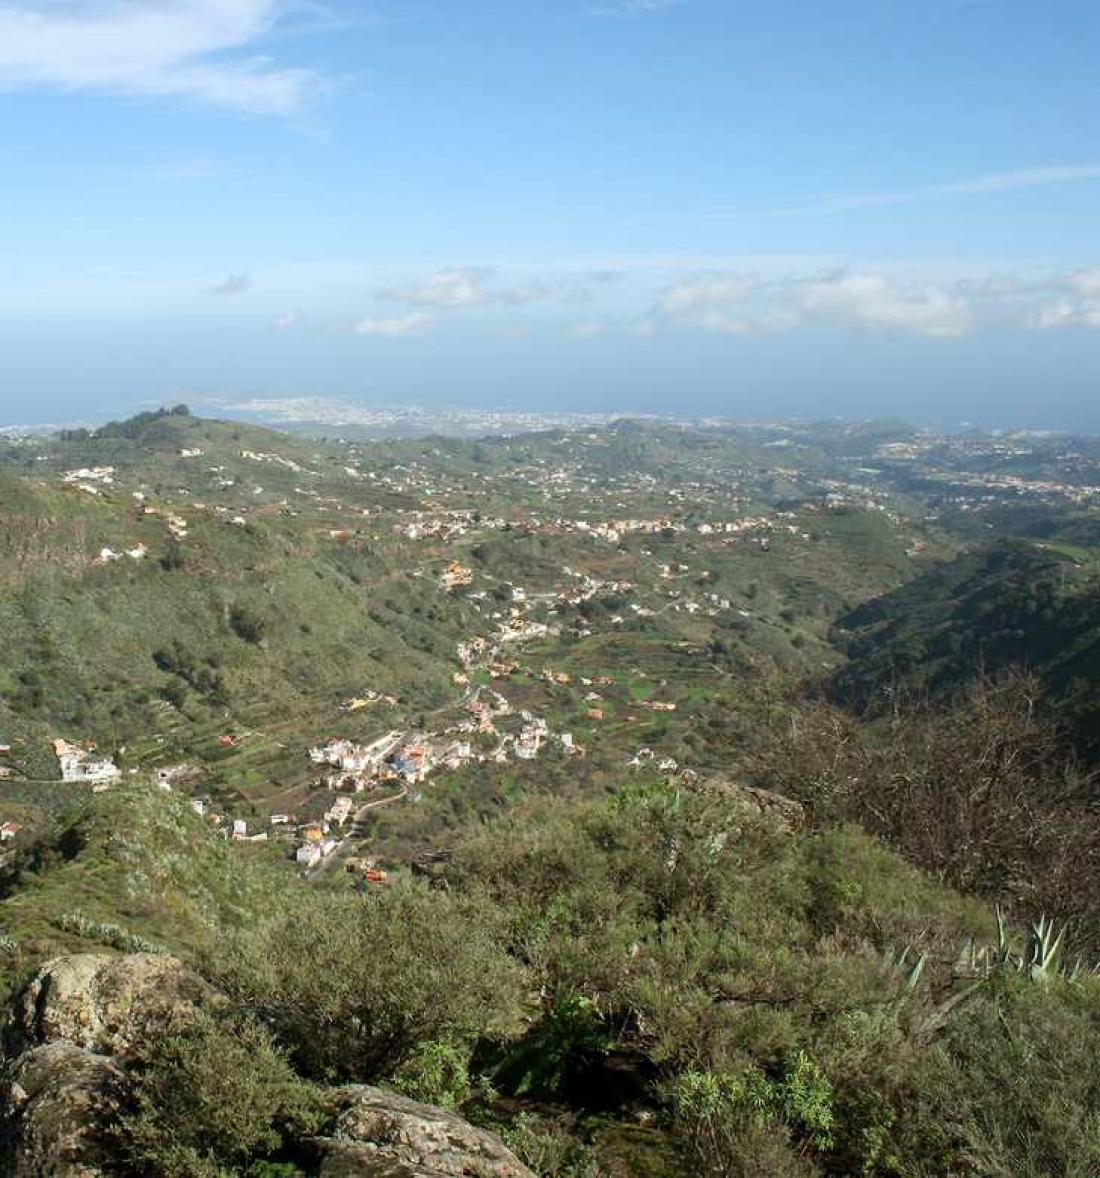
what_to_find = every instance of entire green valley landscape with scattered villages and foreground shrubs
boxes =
[0,406,1100,1178]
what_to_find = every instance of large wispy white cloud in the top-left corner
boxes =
[0,0,319,115]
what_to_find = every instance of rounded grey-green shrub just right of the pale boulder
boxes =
[211,885,532,1080]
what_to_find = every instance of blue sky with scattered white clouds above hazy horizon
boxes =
[0,0,1100,432]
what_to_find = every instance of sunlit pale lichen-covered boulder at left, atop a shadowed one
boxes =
[8,953,216,1055]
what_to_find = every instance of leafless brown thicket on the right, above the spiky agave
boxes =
[757,674,1100,944]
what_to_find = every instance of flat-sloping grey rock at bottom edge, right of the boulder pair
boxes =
[318,1087,534,1178]
